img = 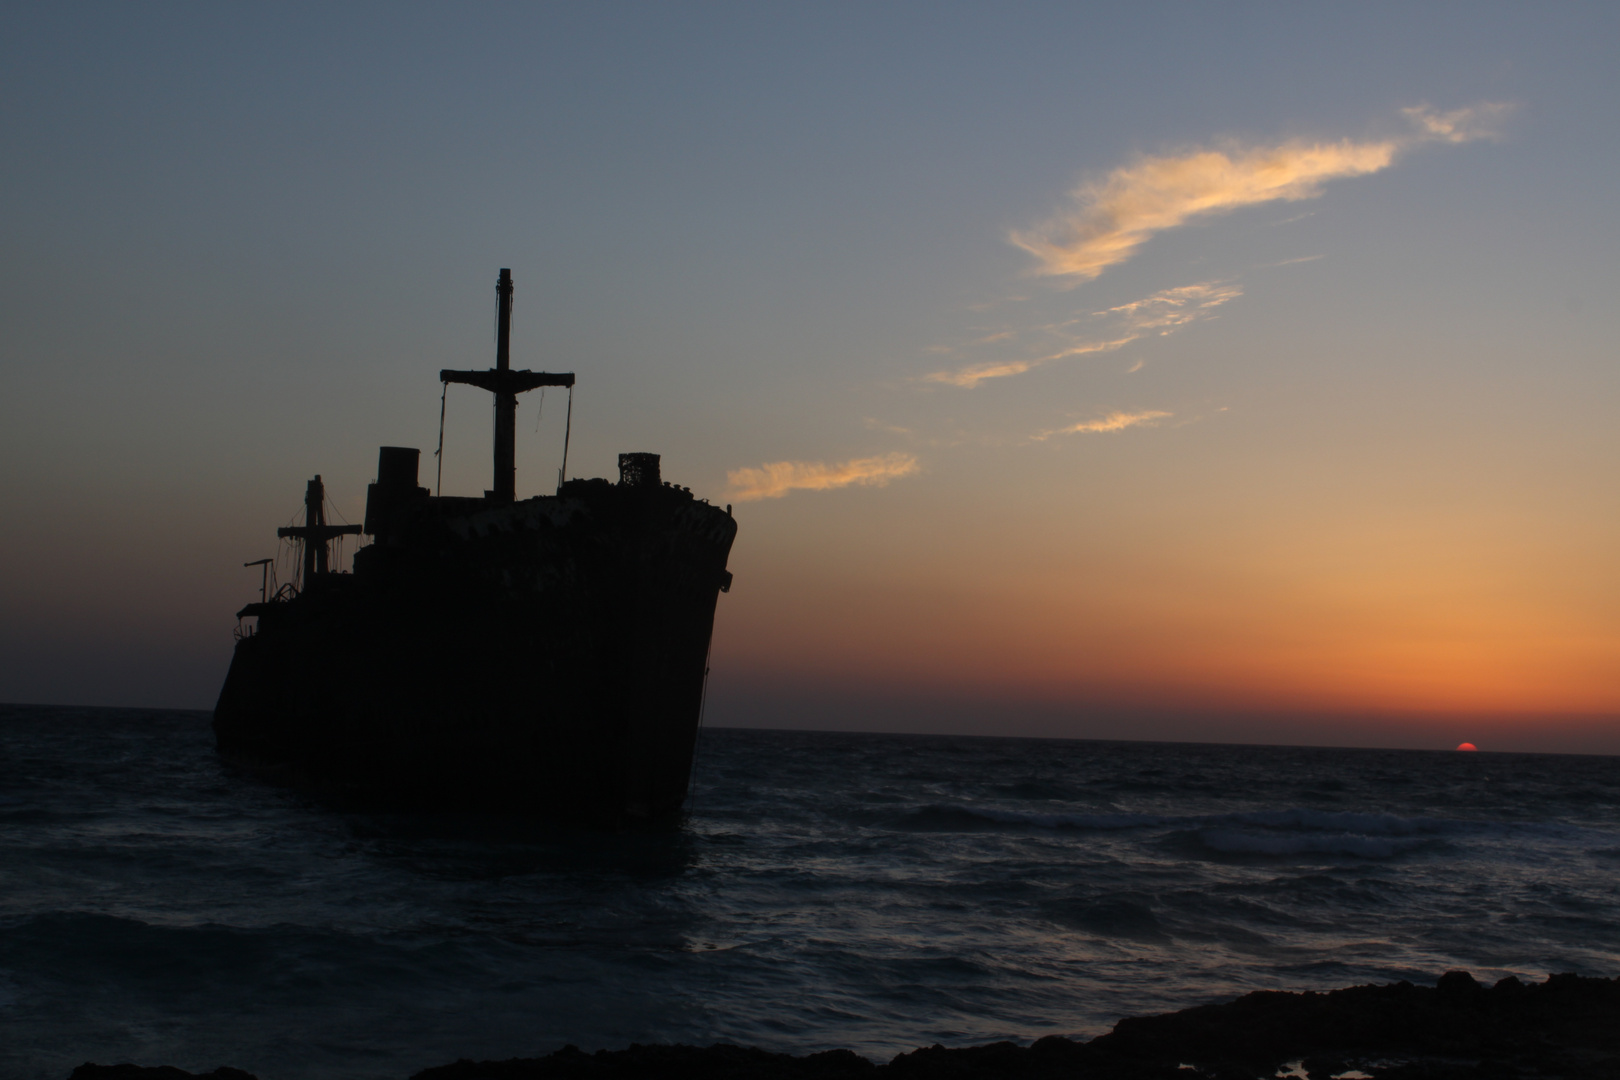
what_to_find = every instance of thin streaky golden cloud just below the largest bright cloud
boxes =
[923,282,1243,390]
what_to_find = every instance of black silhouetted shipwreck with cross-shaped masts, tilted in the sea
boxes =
[214,270,737,823]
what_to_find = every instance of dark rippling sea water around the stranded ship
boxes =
[0,706,1620,1080]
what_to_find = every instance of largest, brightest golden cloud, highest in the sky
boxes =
[1009,104,1510,285]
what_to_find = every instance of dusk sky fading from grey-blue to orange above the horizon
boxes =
[0,2,1620,753]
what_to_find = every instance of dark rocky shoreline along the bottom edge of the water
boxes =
[70,972,1620,1080]
